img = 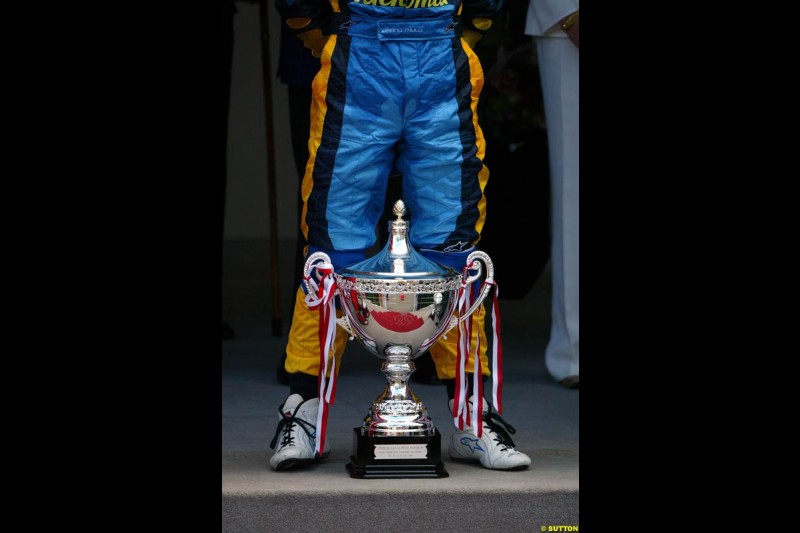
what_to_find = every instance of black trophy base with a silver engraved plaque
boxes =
[346,428,450,479]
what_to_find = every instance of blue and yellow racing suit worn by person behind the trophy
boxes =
[276,0,503,378]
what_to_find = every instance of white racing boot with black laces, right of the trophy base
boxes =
[447,398,531,470]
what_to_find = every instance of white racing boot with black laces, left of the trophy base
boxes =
[269,394,331,470]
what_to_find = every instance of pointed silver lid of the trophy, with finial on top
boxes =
[341,200,461,280]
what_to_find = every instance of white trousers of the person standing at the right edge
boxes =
[536,37,580,381]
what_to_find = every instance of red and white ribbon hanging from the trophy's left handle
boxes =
[303,263,337,454]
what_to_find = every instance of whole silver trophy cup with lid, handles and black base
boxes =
[304,200,494,478]
